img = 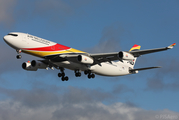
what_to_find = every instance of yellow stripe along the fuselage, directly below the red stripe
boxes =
[23,48,86,57]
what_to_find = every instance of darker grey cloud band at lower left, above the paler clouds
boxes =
[0,85,112,108]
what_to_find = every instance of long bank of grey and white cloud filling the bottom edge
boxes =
[0,86,179,120]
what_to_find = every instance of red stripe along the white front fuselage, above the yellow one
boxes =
[22,43,70,51]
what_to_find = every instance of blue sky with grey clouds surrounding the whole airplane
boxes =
[0,0,179,120]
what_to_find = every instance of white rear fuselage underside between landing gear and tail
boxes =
[92,62,129,76]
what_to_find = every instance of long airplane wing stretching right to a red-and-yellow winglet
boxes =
[43,43,176,66]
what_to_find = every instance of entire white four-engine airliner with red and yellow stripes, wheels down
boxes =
[4,32,176,81]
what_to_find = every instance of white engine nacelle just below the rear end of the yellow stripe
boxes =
[78,55,94,64]
